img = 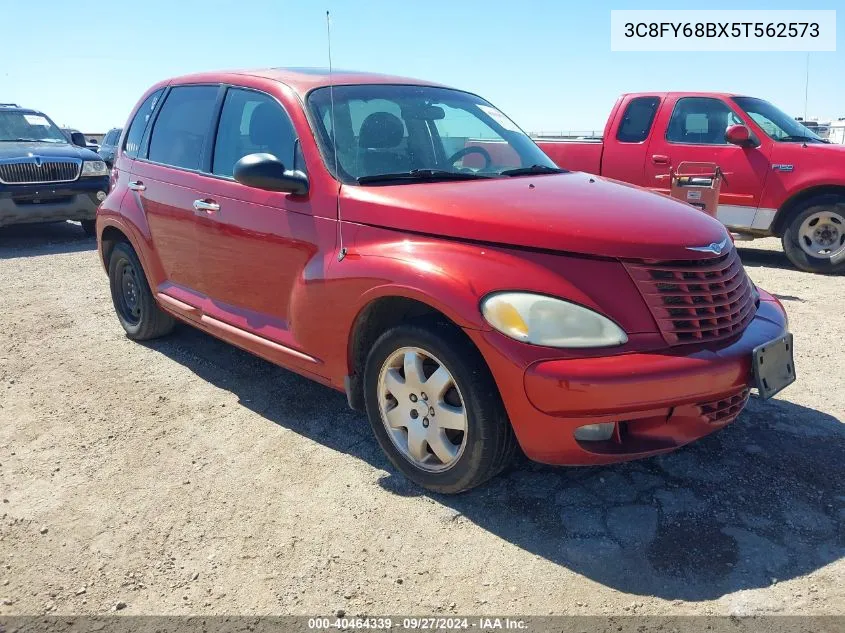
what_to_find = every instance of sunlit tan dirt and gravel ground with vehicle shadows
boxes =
[0,224,845,615]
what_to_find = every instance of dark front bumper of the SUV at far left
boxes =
[0,176,109,226]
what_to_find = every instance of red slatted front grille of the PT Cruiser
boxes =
[625,248,757,345]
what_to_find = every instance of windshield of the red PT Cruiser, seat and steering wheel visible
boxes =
[308,85,562,185]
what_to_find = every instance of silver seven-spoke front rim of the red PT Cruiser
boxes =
[377,347,468,472]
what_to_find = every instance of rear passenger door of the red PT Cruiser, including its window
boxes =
[129,85,220,306]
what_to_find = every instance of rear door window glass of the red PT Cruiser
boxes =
[147,86,218,170]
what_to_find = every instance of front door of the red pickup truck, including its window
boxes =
[645,96,770,229]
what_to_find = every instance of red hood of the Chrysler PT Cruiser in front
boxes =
[341,172,728,260]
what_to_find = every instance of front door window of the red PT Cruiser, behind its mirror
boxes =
[210,88,296,177]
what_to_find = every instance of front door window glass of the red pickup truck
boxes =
[666,97,742,145]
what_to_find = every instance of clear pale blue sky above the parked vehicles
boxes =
[0,0,845,133]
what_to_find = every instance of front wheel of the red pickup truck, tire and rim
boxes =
[781,195,845,274]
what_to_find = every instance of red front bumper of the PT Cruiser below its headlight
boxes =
[471,291,787,465]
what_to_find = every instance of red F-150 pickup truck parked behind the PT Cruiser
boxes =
[537,92,845,273]
